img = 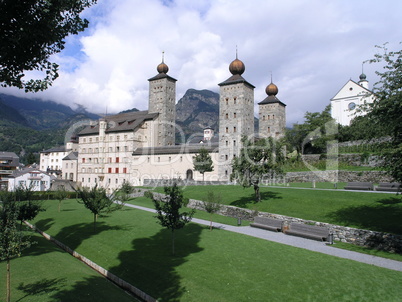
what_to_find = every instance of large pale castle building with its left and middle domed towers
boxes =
[75,55,285,190]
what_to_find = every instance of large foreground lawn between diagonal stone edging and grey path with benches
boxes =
[11,200,402,301]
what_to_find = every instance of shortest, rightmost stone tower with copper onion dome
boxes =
[258,79,286,138]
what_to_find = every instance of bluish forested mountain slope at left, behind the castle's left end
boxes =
[0,94,99,163]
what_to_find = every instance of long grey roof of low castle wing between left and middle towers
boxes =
[133,144,219,156]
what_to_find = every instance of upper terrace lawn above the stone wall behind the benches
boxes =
[153,185,402,234]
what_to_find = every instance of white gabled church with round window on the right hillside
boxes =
[331,74,374,126]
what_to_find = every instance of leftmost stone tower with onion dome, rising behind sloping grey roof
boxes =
[148,57,177,147]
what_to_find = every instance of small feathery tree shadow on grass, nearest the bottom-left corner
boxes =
[17,278,66,301]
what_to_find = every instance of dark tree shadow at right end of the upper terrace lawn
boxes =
[328,197,402,235]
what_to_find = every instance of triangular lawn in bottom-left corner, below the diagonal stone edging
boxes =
[0,233,137,302]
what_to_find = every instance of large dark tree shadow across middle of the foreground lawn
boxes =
[110,223,204,302]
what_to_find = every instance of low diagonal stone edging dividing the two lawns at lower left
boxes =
[25,221,157,302]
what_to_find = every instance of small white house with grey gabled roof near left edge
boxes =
[8,168,54,191]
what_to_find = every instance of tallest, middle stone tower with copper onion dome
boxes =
[218,54,255,181]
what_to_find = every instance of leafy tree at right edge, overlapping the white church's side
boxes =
[368,44,402,182]
